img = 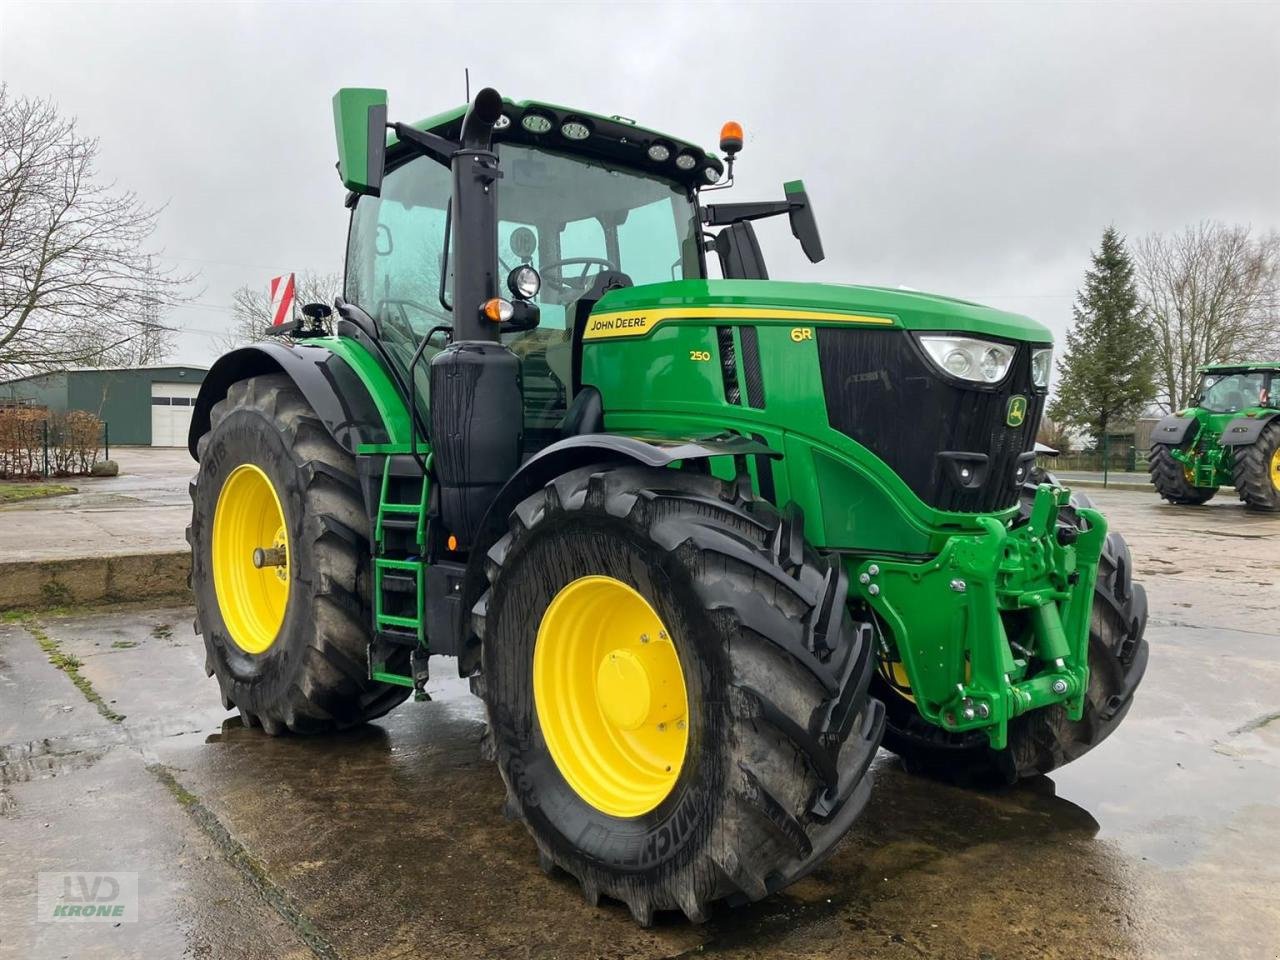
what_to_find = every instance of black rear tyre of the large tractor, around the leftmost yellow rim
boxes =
[187,374,410,735]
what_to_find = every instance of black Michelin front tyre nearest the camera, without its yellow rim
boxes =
[474,466,882,925]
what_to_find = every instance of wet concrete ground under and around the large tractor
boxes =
[0,490,1280,960]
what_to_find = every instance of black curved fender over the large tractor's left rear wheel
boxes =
[187,343,389,460]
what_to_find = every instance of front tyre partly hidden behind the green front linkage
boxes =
[872,476,1147,786]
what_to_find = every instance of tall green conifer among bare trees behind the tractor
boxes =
[1048,227,1156,443]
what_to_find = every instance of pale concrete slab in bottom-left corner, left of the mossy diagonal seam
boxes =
[0,616,315,960]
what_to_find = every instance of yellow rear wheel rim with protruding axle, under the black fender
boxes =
[212,463,289,653]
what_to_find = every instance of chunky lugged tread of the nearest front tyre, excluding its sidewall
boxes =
[472,466,882,924]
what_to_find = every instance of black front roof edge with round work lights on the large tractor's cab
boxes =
[387,97,724,189]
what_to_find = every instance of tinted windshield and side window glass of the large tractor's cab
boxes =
[343,143,704,438]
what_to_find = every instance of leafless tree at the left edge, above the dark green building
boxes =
[0,84,192,376]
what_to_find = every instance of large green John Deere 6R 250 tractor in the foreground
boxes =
[189,90,1147,923]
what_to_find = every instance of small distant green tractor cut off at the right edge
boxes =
[1147,361,1280,511]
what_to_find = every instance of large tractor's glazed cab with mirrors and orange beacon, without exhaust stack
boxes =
[335,91,820,458]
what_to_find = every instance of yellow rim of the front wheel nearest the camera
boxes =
[534,576,689,817]
